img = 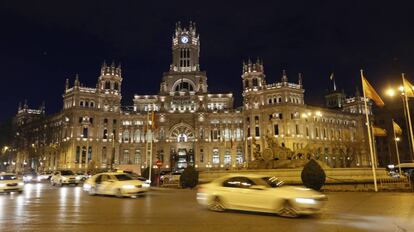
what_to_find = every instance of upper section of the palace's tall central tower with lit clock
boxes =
[170,22,200,72]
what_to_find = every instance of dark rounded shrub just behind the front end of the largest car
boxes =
[301,159,326,191]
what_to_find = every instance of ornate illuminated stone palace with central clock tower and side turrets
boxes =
[13,23,369,170]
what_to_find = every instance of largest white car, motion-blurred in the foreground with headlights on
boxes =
[197,174,327,217]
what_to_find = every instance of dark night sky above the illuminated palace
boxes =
[0,0,414,119]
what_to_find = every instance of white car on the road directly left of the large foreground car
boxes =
[83,172,149,197]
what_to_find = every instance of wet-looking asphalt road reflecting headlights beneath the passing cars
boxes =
[0,184,414,232]
